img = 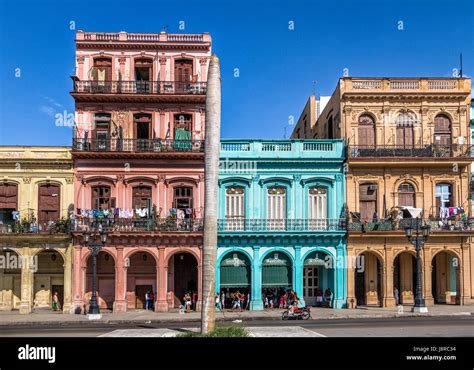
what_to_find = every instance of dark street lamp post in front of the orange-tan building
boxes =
[405,218,430,313]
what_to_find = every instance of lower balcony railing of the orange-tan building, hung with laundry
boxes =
[347,218,474,232]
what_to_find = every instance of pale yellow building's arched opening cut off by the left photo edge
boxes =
[0,249,21,311]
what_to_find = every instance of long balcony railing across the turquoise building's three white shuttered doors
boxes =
[217,218,346,232]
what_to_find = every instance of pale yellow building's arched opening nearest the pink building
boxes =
[33,250,64,309]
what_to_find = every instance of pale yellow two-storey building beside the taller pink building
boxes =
[0,146,74,313]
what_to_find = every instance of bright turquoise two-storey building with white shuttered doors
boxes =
[216,140,346,310]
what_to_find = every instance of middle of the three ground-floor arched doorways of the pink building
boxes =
[127,252,157,309]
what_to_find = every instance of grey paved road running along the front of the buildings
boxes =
[0,316,474,337]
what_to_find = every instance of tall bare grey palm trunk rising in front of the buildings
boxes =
[201,55,221,334]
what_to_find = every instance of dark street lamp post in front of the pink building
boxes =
[82,229,107,320]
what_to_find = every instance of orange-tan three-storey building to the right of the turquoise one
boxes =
[294,77,474,307]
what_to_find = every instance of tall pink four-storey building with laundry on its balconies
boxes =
[71,31,211,312]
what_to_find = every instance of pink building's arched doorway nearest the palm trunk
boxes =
[168,252,199,308]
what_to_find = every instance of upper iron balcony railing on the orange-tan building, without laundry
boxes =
[349,144,474,158]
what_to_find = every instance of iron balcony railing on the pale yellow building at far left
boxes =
[0,220,70,235]
